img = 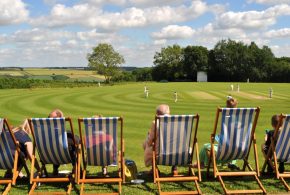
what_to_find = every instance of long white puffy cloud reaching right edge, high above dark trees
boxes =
[217,4,290,30]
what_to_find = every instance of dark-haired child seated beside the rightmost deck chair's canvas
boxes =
[262,114,284,173]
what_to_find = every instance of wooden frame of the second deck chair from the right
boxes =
[207,107,266,194]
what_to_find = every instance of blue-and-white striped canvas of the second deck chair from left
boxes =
[31,118,71,165]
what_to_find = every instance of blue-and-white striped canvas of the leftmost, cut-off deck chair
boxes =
[0,118,14,169]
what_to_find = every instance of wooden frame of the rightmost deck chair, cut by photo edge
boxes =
[262,114,290,191]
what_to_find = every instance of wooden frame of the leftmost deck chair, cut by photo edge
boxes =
[0,118,29,195]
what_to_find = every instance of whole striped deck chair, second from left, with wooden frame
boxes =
[28,118,77,194]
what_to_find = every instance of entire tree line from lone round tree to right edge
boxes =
[88,39,290,82]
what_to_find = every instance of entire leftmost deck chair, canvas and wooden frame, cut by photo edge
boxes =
[0,118,28,194]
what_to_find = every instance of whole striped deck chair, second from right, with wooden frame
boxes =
[207,108,266,194]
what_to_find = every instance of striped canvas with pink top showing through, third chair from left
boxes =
[83,117,119,166]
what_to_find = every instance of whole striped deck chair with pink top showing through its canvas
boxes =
[77,117,125,194]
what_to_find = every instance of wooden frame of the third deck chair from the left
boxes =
[77,117,125,194]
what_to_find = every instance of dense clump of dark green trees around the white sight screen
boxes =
[152,39,290,82]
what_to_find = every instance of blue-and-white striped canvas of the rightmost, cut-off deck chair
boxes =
[276,115,290,162]
